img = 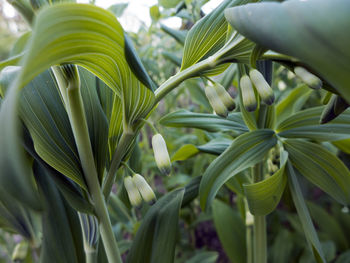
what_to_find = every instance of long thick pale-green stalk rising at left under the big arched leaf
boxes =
[67,83,122,263]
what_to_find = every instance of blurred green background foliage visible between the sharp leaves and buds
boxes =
[0,0,350,263]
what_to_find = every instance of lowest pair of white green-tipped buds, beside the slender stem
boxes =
[124,174,156,206]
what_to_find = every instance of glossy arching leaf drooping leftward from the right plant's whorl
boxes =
[200,129,277,209]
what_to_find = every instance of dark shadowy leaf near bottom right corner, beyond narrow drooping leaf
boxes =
[307,202,349,251]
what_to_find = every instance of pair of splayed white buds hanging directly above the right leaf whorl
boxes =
[240,69,275,111]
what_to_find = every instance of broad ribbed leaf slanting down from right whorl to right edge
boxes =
[284,139,350,205]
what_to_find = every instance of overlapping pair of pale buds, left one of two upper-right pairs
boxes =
[204,83,236,117]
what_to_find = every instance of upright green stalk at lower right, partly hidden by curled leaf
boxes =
[253,163,267,263]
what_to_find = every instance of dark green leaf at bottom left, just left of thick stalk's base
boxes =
[34,163,85,263]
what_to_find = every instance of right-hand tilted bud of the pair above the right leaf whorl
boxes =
[249,69,275,105]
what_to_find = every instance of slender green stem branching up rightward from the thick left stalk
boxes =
[103,131,136,199]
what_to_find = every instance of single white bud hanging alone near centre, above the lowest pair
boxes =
[152,133,171,175]
